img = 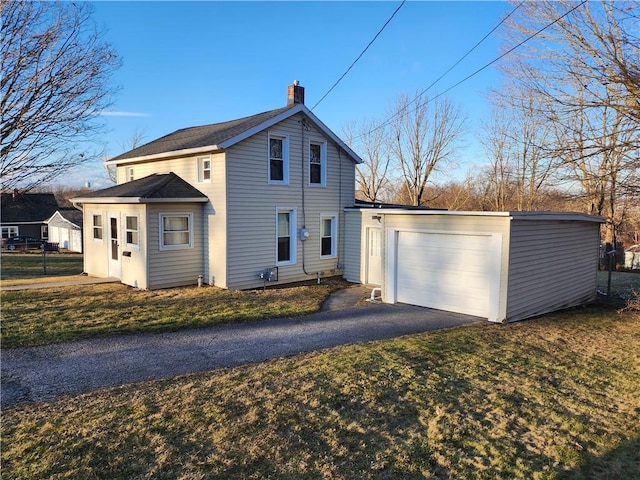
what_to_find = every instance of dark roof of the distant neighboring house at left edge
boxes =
[0,193,59,224]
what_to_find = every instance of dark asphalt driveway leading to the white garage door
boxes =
[0,292,482,408]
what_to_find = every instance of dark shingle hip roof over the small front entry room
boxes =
[73,172,207,203]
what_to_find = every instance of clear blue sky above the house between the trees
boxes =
[74,1,511,188]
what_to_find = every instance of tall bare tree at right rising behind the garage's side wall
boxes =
[501,0,640,241]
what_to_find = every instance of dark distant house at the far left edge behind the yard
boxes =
[0,192,58,240]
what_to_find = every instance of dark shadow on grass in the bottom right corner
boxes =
[557,437,640,480]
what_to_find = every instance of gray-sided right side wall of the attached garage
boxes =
[507,219,600,321]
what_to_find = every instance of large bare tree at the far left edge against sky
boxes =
[0,1,119,191]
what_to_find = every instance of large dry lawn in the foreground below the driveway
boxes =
[2,308,640,479]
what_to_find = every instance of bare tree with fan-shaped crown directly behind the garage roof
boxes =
[391,93,465,206]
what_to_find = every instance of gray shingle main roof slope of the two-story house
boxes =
[111,105,295,161]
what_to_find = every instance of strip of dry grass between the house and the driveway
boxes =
[0,280,346,348]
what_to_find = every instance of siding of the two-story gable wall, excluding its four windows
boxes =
[226,115,355,289]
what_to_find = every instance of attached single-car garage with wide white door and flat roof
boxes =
[345,208,602,322]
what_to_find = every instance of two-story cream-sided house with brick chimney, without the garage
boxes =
[72,82,362,289]
